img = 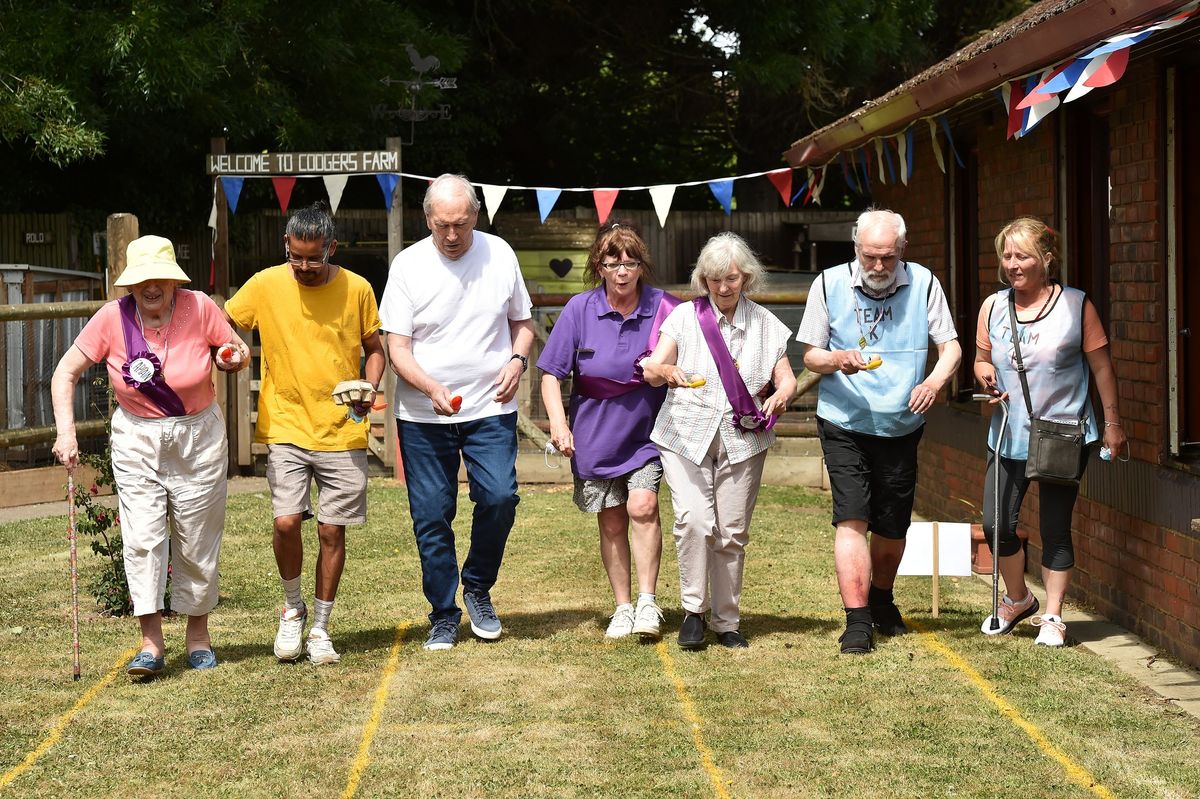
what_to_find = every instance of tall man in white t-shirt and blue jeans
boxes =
[379,174,533,649]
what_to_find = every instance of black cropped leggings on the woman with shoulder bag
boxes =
[983,452,1079,571]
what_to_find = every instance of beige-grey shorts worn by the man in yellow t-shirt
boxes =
[266,444,367,527]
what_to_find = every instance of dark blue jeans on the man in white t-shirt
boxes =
[396,413,521,623]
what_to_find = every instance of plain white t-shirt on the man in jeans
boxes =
[379,230,532,425]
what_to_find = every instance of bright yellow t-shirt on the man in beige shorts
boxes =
[224,264,379,452]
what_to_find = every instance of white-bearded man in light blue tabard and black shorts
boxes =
[796,210,962,654]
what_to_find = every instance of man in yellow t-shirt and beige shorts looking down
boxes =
[224,203,384,663]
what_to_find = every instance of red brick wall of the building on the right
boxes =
[859,61,1200,666]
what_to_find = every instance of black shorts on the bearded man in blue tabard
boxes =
[817,416,925,539]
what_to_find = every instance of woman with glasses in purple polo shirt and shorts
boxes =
[538,222,678,639]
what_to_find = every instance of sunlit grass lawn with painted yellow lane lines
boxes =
[0,481,1200,799]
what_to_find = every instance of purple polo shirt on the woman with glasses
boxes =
[538,284,667,480]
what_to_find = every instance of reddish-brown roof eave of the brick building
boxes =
[784,0,1182,167]
